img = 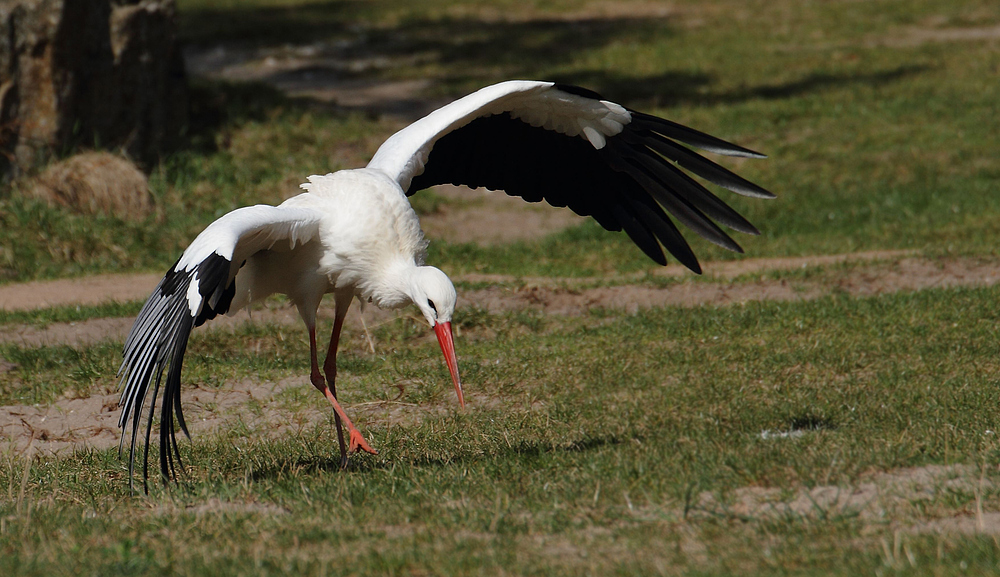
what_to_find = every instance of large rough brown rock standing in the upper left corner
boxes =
[0,0,187,176]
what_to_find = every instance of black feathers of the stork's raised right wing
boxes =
[406,85,774,272]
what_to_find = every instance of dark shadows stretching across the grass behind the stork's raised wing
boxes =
[172,1,925,150]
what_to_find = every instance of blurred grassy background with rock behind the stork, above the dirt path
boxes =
[0,0,1000,282]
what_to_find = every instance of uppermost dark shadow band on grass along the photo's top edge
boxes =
[178,0,671,68]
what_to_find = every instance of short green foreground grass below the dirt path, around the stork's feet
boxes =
[0,288,1000,575]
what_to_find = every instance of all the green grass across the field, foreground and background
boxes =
[0,0,1000,575]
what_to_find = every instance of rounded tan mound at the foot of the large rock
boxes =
[24,152,153,221]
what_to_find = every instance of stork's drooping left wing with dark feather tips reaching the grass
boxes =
[118,205,321,486]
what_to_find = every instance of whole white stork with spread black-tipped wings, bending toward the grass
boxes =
[118,81,774,483]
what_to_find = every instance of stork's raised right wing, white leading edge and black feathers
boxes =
[368,80,774,273]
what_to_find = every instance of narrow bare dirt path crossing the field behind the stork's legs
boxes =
[0,252,1000,347]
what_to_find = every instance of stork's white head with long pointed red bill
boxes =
[409,266,465,407]
